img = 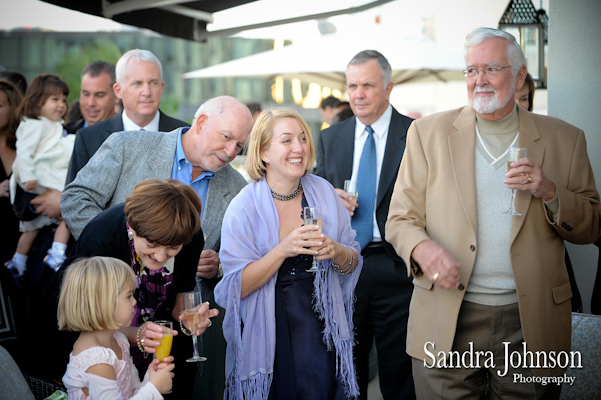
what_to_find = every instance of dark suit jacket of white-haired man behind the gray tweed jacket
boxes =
[65,110,189,186]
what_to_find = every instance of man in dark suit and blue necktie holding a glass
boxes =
[315,50,415,400]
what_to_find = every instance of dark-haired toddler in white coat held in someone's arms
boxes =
[6,74,75,287]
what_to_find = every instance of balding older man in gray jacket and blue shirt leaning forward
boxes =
[61,96,253,398]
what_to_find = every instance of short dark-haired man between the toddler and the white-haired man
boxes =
[65,61,117,133]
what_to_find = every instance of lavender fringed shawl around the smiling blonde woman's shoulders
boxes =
[215,175,363,400]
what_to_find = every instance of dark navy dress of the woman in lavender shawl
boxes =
[269,255,346,400]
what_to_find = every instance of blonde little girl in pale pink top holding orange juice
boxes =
[57,257,175,400]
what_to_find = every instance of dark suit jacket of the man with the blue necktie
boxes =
[315,107,413,262]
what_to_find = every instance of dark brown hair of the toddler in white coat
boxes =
[17,74,69,120]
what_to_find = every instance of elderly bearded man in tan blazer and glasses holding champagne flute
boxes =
[386,28,601,400]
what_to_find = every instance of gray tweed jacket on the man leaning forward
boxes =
[61,128,247,247]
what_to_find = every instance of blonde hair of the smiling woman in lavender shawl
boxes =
[246,107,315,182]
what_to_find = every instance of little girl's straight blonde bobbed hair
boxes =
[57,257,136,332]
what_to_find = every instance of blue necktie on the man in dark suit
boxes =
[351,126,376,249]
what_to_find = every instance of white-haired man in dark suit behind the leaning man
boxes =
[67,49,188,184]
